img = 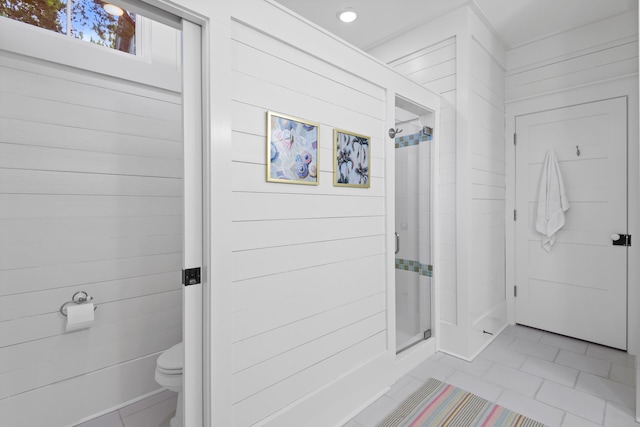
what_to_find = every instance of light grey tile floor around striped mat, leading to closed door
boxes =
[344,326,640,427]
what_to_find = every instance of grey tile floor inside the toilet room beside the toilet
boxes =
[76,390,177,427]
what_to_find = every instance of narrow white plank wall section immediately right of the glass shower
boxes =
[388,37,457,324]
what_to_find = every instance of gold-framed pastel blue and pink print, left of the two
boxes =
[267,111,320,185]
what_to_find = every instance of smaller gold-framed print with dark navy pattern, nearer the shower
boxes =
[333,129,371,188]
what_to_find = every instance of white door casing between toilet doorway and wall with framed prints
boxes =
[150,0,233,427]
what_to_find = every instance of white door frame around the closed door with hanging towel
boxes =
[505,74,640,355]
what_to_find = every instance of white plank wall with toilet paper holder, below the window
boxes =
[0,52,183,426]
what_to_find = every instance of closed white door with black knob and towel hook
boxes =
[516,97,627,349]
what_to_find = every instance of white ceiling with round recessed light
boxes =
[277,0,638,51]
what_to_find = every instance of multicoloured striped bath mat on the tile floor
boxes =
[377,378,544,427]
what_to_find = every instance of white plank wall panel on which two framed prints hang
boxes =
[230,22,386,426]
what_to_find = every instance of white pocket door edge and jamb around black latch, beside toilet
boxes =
[139,0,212,427]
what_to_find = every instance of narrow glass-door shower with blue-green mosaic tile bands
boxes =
[395,97,433,353]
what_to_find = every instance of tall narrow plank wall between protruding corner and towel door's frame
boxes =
[469,38,506,323]
